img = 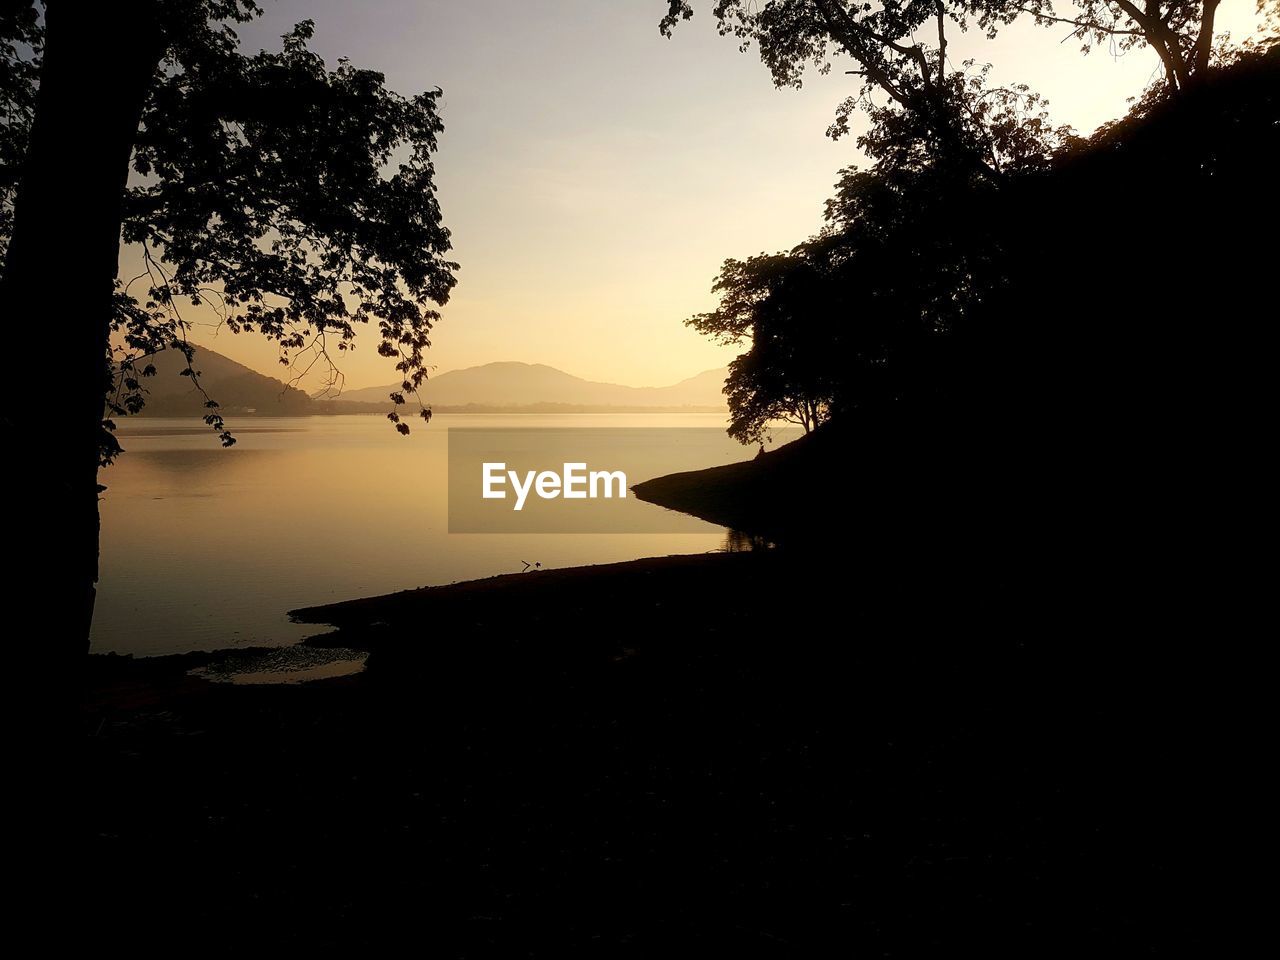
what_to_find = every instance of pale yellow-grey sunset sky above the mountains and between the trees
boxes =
[122,0,1254,388]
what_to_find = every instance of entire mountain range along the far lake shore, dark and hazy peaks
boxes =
[123,347,727,416]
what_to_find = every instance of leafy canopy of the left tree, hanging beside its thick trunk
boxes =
[0,0,457,461]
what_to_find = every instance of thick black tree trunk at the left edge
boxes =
[0,0,164,686]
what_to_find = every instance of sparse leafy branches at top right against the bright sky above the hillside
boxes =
[659,0,1249,172]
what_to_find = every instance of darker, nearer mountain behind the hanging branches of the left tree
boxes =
[120,347,316,417]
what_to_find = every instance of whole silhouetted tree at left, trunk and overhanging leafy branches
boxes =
[0,0,456,662]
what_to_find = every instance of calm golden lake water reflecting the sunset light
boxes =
[92,413,768,654]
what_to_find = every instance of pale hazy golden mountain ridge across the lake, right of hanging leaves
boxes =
[342,361,727,410]
